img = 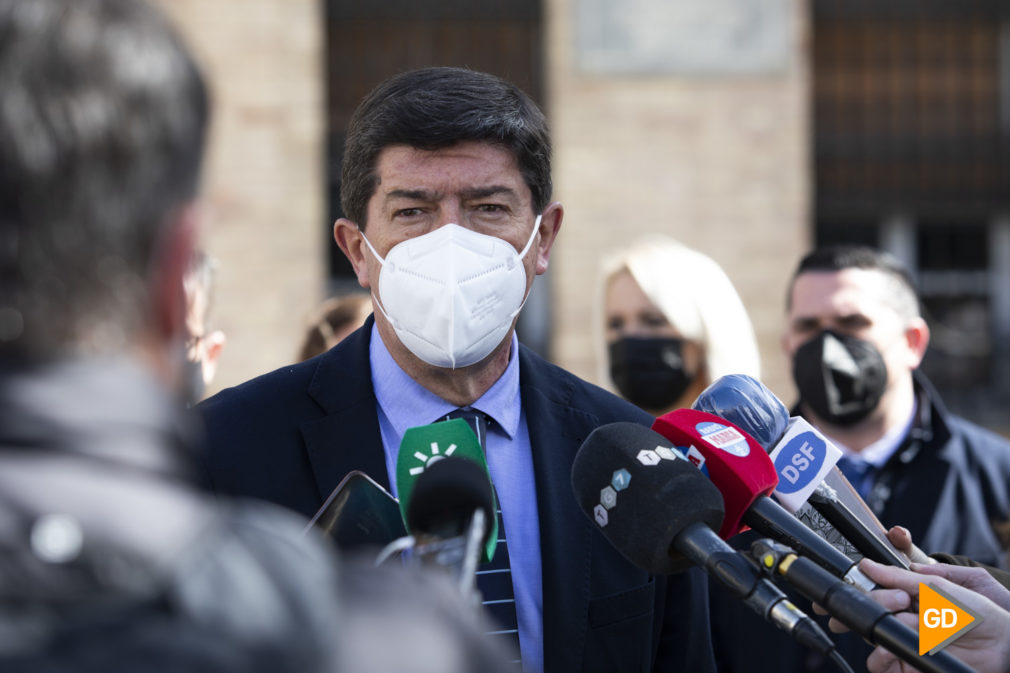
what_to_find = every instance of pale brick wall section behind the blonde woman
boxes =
[546,0,810,401]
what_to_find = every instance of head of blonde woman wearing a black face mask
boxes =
[597,234,761,414]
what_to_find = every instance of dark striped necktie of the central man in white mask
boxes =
[443,407,520,664]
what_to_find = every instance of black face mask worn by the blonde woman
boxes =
[609,337,696,411]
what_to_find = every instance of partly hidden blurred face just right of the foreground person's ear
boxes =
[182,250,227,404]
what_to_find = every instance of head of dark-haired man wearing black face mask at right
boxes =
[783,246,929,438]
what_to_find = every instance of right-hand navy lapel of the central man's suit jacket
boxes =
[519,346,599,671]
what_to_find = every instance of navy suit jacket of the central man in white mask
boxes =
[199,318,714,673]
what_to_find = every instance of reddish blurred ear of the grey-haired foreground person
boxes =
[148,202,199,341]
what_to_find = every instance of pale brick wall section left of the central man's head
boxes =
[155,0,325,391]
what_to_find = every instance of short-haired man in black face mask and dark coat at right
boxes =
[712,247,1010,673]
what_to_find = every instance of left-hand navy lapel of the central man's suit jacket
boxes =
[300,317,389,497]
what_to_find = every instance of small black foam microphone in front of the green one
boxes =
[405,457,496,595]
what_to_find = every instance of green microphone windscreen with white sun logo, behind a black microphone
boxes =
[396,418,498,562]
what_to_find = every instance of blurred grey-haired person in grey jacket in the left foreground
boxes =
[0,0,337,673]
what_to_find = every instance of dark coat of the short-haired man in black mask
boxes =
[712,373,1010,673]
